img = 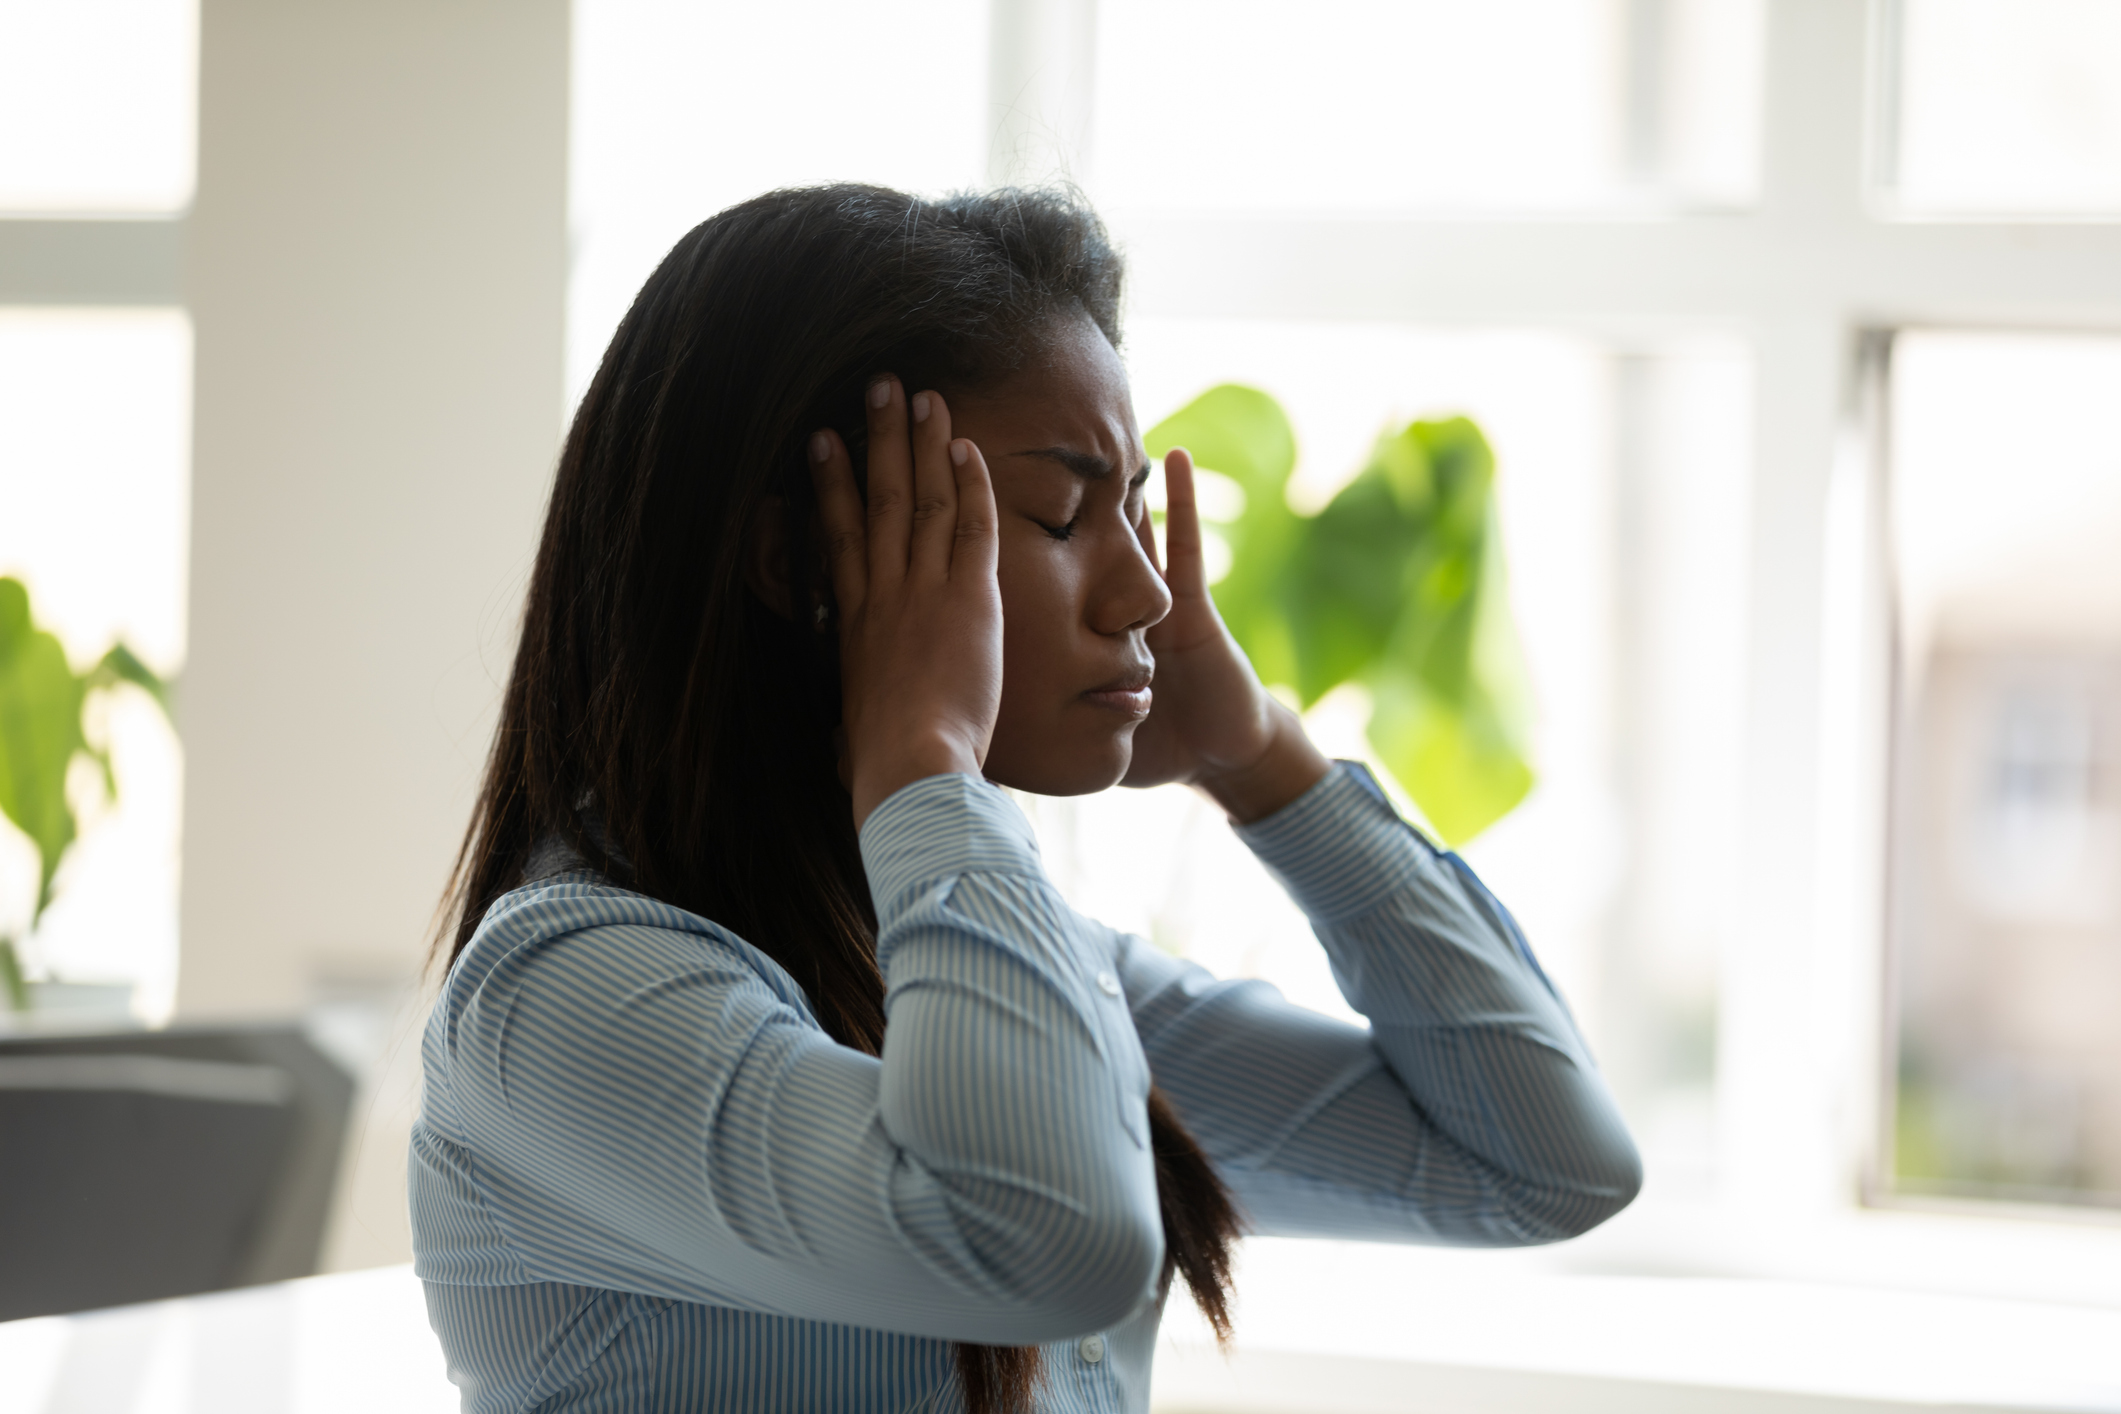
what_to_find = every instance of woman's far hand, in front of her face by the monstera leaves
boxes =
[1120,449,1332,823]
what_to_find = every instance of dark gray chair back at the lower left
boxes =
[0,1026,354,1321]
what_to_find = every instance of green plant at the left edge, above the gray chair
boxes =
[0,579,170,1011]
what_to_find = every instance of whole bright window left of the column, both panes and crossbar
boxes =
[0,0,197,1020]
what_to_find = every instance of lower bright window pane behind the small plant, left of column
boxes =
[0,310,191,1018]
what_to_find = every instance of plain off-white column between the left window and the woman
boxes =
[178,0,568,1018]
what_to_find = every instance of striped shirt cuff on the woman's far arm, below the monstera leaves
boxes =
[1234,761,1438,922]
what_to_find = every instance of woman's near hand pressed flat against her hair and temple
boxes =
[814,377,1001,829]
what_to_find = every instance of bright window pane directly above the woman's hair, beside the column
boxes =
[566,0,988,403]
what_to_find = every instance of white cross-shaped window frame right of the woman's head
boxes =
[1060,0,2121,1304]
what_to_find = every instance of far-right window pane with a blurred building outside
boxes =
[1886,331,2121,1204]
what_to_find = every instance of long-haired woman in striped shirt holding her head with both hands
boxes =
[411,187,1640,1414]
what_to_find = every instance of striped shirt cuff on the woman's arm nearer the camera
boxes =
[861,774,1046,926]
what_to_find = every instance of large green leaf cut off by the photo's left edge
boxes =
[0,579,89,926]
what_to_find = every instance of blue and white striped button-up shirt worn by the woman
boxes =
[411,763,1640,1414]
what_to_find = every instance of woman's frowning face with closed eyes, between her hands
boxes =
[950,318,1171,795]
